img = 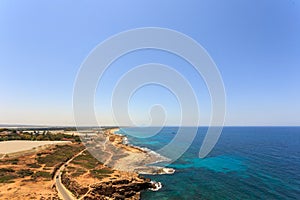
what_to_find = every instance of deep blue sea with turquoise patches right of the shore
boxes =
[120,127,300,200]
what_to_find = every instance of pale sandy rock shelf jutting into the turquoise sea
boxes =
[86,129,175,174]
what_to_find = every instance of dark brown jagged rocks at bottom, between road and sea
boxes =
[62,162,160,200]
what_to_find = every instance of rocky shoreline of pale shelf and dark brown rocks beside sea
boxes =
[71,129,174,200]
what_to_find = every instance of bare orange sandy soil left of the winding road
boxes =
[0,141,83,200]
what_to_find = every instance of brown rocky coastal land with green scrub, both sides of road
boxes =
[0,129,170,200]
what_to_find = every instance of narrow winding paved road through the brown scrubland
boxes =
[54,149,86,200]
